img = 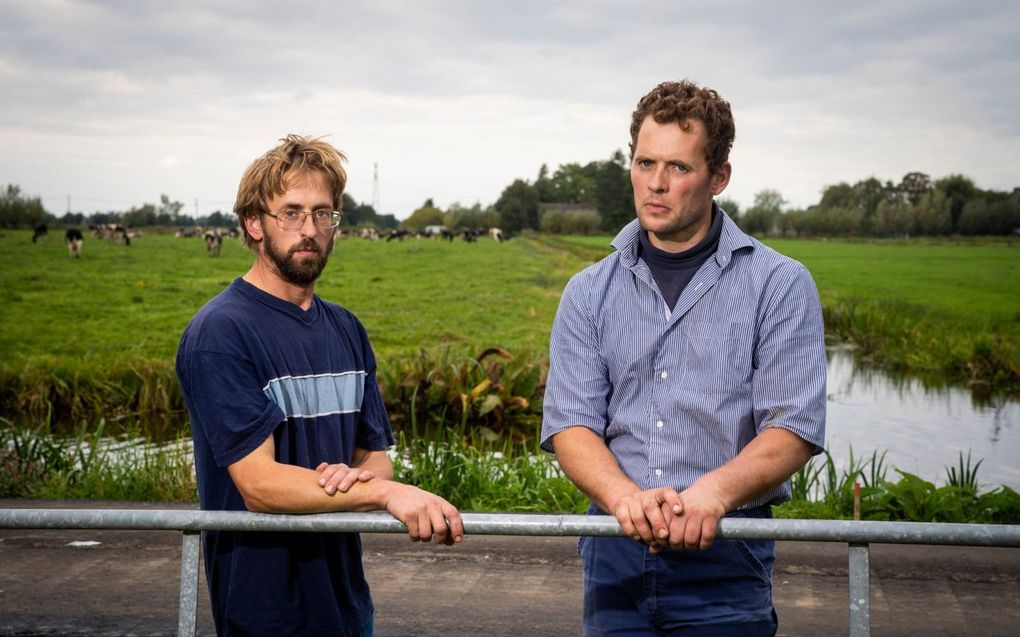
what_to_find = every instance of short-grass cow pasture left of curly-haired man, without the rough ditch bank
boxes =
[0,231,583,368]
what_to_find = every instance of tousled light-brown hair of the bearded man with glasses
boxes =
[234,135,347,251]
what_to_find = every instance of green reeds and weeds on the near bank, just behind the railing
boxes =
[0,419,1020,524]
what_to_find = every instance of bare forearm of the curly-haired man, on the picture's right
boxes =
[689,428,813,511]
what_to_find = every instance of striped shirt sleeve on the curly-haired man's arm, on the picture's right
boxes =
[753,262,825,454]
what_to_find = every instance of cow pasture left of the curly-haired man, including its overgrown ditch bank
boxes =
[0,231,583,436]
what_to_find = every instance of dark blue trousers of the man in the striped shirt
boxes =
[580,507,778,637]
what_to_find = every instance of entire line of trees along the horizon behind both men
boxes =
[0,161,1020,236]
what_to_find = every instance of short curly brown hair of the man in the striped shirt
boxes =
[630,79,736,173]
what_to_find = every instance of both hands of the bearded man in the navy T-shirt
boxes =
[315,463,464,545]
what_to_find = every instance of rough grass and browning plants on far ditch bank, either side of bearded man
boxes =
[0,348,547,441]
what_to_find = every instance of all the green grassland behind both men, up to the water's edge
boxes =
[0,230,1020,432]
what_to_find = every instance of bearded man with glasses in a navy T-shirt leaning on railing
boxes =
[176,136,463,637]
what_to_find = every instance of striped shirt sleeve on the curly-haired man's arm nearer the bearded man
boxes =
[542,275,611,452]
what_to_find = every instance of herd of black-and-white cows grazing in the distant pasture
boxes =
[32,223,506,259]
